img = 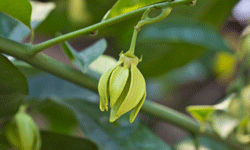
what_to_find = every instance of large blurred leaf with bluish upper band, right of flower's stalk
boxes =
[135,18,229,77]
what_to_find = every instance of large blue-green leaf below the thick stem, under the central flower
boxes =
[25,74,170,150]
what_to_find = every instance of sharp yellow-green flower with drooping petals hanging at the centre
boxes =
[98,54,146,123]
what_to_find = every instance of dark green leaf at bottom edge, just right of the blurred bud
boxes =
[41,131,98,150]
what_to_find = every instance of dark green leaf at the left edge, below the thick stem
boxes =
[0,54,29,118]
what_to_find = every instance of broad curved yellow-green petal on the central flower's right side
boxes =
[117,64,146,116]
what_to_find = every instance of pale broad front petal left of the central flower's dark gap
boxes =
[109,66,129,108]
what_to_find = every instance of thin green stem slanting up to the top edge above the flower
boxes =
[29,0,192,55]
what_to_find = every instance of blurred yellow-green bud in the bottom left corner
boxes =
[5,107,41,150]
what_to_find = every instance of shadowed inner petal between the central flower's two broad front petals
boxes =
[109,77,131,122]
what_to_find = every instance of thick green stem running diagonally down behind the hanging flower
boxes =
[0,37,246,148]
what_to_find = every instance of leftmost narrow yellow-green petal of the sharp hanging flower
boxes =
[98,61,122,111]
